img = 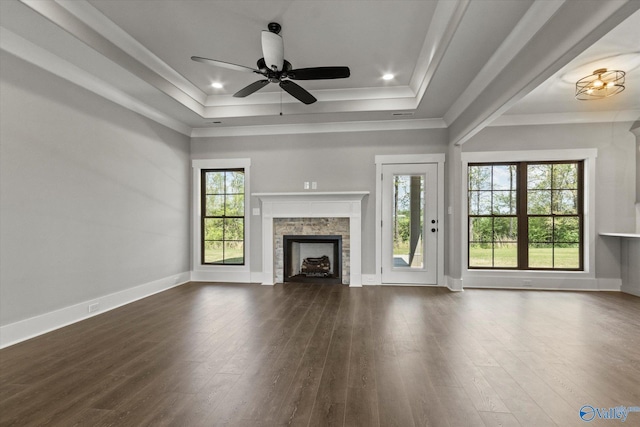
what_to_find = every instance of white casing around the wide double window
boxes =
[460,148,598,289]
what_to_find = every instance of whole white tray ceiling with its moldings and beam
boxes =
[0,0,640,143]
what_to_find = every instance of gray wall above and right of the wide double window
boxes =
[463,123,636,278]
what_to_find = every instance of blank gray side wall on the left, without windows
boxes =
[0,53,191,325]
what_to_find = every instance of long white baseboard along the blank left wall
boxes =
[0,272,191,348]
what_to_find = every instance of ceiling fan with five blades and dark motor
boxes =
[191,22,351,104]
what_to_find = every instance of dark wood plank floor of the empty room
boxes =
[0,283,640,427]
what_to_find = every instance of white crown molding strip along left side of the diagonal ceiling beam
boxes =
[444,0,566,124]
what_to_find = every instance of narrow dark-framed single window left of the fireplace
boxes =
[200,169,245,265]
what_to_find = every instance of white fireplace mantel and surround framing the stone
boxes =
[251,191,369,287]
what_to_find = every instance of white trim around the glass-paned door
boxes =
[375,153,447,286]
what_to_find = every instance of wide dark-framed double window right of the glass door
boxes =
[468,161,584,271]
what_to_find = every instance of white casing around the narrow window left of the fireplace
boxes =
[191,159,251,283]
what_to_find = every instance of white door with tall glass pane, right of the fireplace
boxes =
[382,163,438,285]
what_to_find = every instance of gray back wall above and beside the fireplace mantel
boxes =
[191,129,447,274]
